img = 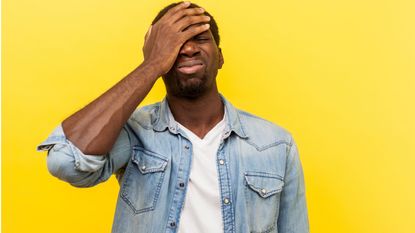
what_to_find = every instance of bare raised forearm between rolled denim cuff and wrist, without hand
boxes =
[62,63,159,155]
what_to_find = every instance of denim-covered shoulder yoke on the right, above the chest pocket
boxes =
[238,109,292,148]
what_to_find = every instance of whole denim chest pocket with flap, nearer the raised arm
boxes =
[121,146,168,214]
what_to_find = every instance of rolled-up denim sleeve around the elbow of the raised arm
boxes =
[37,125,131,187]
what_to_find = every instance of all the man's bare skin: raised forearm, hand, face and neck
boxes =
[62,2,224,155]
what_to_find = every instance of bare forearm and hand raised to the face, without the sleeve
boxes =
[62,3,209,155]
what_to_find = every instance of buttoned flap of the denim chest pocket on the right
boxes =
[245,172,284,198]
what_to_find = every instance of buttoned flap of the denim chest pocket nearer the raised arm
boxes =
[132,146,169,174]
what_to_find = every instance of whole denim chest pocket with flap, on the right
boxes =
[245,172,284,233]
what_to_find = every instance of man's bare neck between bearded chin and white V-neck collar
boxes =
[167,92,225,138]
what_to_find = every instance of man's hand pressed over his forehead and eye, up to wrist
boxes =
[143,2,210,76]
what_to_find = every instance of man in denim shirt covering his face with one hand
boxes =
[38,2,309,233]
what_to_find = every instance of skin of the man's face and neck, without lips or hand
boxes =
[163,28,224,138]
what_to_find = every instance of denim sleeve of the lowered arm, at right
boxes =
[278,137,310,233]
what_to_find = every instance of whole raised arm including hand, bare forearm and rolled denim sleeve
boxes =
[38,3,213,187]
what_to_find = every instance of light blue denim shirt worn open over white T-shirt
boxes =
[38,97,309,233]
